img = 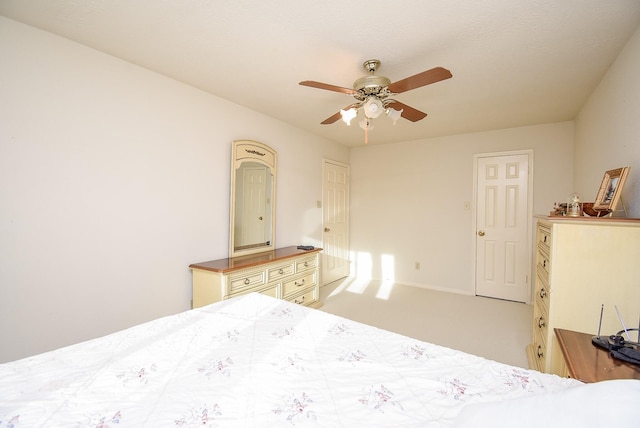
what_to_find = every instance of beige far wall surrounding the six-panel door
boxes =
[351,122,573,294]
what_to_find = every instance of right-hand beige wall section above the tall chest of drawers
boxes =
[575,24,640,218]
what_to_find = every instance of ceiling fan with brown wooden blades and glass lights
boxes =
[300,59,452,139]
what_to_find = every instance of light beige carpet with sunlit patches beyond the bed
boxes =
[320,277,533,368]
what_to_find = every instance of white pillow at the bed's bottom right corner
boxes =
[454,379,640,428]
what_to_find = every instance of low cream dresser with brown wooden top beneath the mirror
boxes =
[189,247,322,308]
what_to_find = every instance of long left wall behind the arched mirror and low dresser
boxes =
[0,18,349,362]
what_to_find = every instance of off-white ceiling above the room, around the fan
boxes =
[0,0,640,146]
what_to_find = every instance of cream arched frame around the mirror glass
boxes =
[229,140,277,258]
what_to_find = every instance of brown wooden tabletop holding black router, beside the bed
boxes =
[554,328,640,383]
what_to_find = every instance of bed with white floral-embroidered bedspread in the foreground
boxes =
[0,293,640,428]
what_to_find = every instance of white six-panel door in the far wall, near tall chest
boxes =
[475,153,531,302]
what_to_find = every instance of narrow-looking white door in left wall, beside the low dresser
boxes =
[322,160,349,285]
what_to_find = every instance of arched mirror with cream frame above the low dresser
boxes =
[229,140,276,257]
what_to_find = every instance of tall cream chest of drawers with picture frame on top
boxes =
[527,217,640,376]
